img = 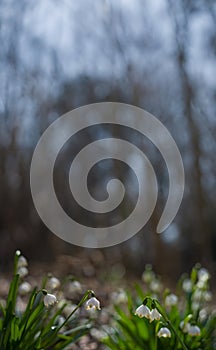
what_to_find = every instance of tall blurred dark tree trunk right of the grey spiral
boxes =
[168,0,212,263]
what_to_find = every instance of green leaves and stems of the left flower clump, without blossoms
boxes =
[0,251,93,350]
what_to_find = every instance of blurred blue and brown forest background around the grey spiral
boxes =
[0,0,216,276]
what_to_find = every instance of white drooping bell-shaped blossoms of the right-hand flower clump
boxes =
[130,266,212,346]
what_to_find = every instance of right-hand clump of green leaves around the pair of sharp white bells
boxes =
[103,265,216,350]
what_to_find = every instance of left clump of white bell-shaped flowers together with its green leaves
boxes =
[0,251,103,350]
